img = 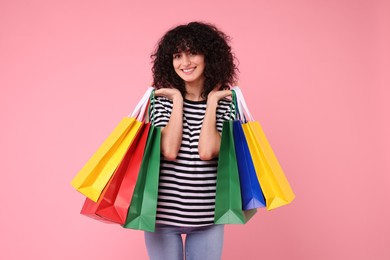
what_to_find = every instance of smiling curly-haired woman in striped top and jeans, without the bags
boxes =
[145,22,237,260]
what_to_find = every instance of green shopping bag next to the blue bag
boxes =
[214,120,256,224]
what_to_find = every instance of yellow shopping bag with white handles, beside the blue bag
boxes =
[233,87,295,210]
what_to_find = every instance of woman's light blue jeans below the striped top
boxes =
[145,224,224,260]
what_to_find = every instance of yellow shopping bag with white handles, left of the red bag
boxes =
[71,87,153,202]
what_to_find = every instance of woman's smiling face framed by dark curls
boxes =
[173,51,205,86]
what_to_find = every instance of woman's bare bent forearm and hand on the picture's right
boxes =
[198,90,232,160]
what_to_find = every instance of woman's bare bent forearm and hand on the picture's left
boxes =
[155,88,183,161]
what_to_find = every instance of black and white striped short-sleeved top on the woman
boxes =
[151,97,234,227]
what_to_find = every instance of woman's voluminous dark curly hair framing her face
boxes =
[151,22,238,98]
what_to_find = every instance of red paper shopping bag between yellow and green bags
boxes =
[81,123,150,225]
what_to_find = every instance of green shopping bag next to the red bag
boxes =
[123,125,161,232]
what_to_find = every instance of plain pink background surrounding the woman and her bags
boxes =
[0,0,390,260]
